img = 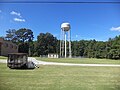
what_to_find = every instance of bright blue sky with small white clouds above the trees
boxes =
[0,0,120,41]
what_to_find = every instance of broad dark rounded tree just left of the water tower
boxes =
[36,33,58,56]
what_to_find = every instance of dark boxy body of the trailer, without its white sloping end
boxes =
[7,53,28,68]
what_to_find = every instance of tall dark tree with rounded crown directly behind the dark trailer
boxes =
[15,28,34,56]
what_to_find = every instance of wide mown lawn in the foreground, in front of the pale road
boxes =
[0,64,120,90]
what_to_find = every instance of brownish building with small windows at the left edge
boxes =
[0,38,18,56]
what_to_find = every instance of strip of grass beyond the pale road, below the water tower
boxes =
[35,57,120,64]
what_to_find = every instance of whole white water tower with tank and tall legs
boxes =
[60,23,71,58]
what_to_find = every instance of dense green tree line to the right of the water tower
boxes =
[72,36,120,60]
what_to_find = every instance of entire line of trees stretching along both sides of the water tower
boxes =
[4,28,120,60]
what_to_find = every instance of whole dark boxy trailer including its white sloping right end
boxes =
[7,53,39,69]
